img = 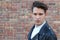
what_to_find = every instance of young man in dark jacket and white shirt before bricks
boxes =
[28,1,57,40]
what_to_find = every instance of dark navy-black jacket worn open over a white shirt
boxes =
[28,22,57,40]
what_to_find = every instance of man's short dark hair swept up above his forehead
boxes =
[32,1,48,12]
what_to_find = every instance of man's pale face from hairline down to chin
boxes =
[32,7,46,25]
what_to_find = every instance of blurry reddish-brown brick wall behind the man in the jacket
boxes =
[0,0,60,40]
